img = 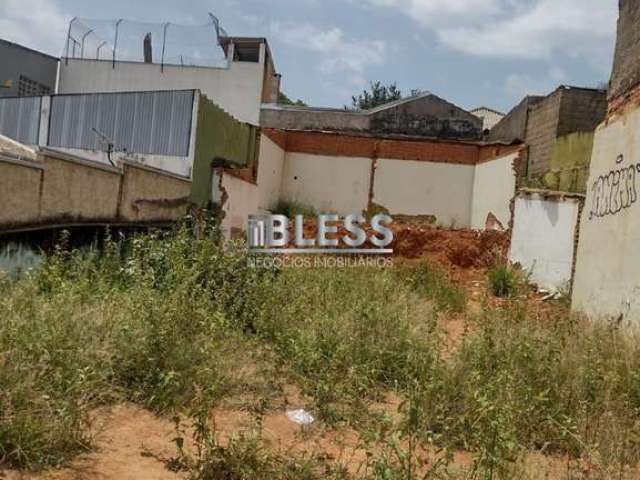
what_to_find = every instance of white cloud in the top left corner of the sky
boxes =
[0,0,68,55]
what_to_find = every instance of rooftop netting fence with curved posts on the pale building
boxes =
[64,13,228,68]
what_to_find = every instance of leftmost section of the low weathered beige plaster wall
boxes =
[0,155,43,228]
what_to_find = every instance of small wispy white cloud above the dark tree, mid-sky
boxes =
[271,23,386,77]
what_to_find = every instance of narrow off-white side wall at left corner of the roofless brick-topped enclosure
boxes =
[258,135,285,210]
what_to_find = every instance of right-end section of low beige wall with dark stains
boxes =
[118,163,191,223]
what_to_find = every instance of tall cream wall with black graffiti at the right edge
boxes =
[572,105,640,325]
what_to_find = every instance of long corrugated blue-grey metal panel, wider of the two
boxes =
[48,90,194,157]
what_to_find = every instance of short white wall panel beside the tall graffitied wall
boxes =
[509,194,579,291]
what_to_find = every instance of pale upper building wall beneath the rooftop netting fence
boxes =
[58,56,264,125]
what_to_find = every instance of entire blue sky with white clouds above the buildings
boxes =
[0,0,618,110]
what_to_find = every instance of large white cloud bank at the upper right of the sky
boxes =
[358,0,617,70]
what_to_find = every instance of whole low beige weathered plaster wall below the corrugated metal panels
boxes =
[0,150,191,231]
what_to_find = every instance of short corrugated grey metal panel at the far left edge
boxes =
[0,97,42,145]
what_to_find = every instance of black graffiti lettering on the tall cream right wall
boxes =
[589,155,640,220]
